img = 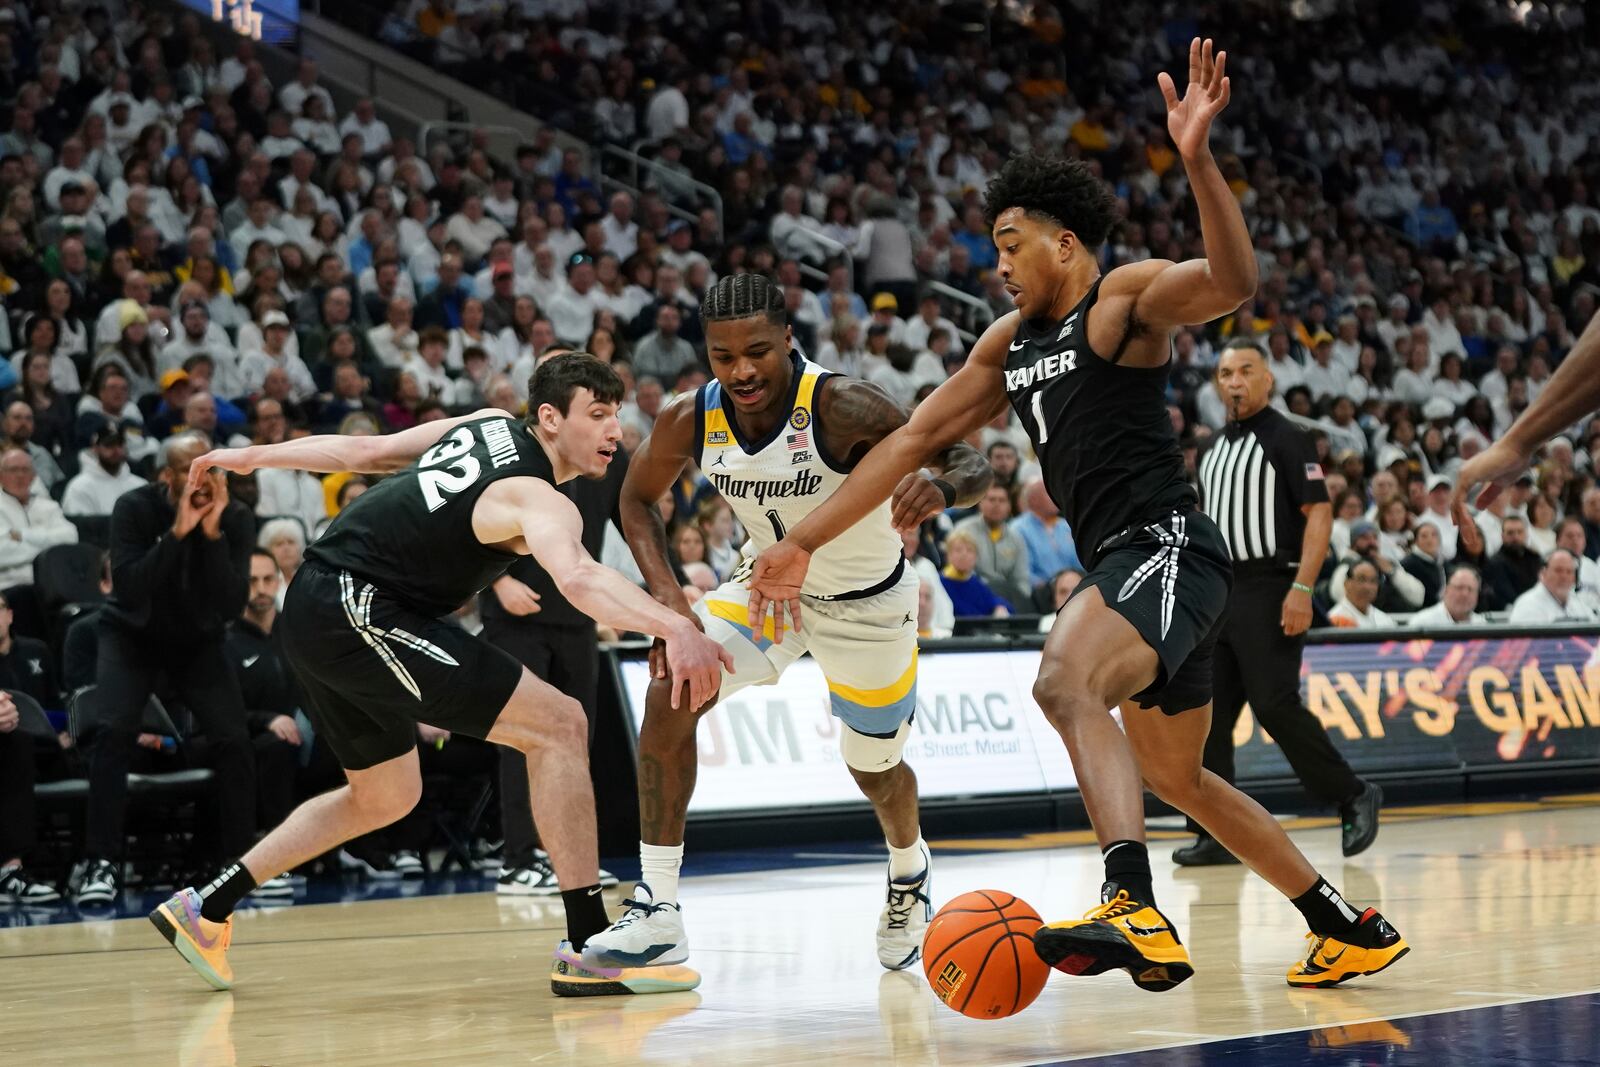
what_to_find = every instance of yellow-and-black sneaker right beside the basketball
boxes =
[1034,886,1195,993]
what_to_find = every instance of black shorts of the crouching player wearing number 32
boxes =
[277,560,522,771]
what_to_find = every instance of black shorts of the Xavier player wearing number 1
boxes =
[1083,512,1234,715]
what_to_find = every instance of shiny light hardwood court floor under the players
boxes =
[0,806,1600,1067]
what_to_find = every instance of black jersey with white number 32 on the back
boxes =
[306,416,555,616]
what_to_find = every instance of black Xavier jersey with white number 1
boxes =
[1005,278,1195,566]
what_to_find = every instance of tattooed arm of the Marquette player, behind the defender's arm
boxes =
[818,376,994,530]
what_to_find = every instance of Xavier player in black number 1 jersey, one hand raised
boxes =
[750,40,1406,992]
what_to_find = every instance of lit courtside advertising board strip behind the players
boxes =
[619,633,1600,814]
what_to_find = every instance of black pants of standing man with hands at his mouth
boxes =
[85,619,256,859]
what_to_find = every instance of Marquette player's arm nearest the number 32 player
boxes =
[618,394,696,617]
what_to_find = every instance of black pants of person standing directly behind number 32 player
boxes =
[483,617,600,867]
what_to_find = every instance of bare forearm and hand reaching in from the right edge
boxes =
[1450,303,1600,552]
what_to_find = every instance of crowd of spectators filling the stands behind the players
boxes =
[0,0,1600,899]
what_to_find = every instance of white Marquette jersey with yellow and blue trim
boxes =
[696,352,902,598]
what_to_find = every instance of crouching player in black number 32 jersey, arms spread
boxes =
[150,354,733,995]
